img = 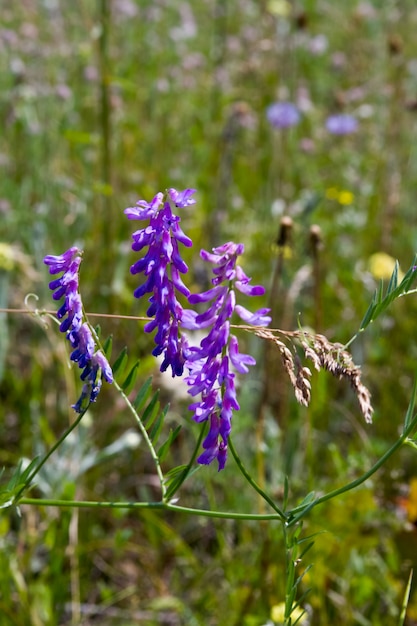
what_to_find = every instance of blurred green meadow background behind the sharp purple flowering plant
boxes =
[0,0,417,626]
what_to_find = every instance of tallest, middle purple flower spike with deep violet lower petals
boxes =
[125,188,195,376]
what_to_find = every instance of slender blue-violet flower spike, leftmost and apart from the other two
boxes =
[43,247,113,413]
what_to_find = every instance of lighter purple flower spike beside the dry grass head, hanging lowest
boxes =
[182,242,271,471]
